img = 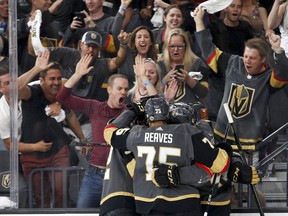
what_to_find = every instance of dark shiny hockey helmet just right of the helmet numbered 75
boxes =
[169,102,197,124]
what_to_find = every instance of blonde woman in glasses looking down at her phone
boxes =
[158,28,209,103]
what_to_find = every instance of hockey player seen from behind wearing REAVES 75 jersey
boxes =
[104,98,231,216]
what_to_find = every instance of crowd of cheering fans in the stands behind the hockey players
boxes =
[0,0,288,215]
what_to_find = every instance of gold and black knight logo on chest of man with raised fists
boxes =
[228,83,255,119]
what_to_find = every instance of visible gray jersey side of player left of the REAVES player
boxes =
[100,148,139,216]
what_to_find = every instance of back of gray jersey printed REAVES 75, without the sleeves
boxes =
[127,124,201,215]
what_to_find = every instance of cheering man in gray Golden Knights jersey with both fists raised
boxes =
[194,7,288,150]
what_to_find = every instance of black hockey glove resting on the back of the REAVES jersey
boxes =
[152,164,180,187]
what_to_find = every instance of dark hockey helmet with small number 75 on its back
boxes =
[145,97,169,122]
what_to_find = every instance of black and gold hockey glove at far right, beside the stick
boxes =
[227,162,260,185]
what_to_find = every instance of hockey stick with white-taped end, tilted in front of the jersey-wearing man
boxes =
[223,103,264,216]
